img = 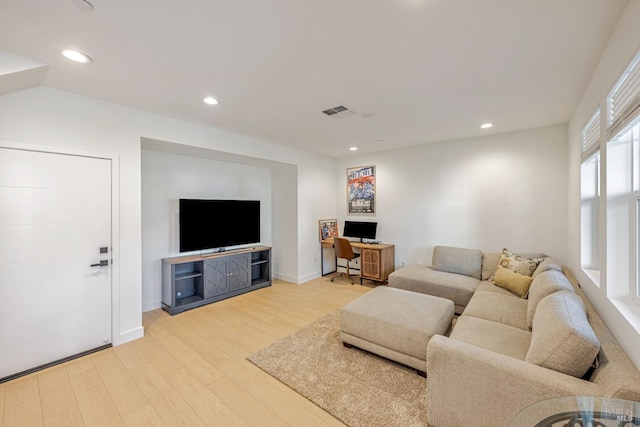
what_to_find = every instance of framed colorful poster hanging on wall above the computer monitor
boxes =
[347,166,376,215]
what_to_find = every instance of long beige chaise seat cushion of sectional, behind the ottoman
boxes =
[389,264,480,313]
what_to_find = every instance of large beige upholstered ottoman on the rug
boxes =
[340,286,454,376]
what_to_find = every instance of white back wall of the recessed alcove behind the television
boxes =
[142,150,272,311]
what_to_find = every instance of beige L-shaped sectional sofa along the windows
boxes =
[389,247,640,427]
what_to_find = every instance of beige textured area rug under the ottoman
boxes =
[247,311,427,427]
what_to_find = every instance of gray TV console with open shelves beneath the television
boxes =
[162,246,271,314]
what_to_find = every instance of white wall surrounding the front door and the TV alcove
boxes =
[0,87,336,345]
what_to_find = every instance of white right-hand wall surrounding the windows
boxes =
[568,1,640,368]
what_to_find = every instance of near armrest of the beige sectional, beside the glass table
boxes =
[427,335,603,427]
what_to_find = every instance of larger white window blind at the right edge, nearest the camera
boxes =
[607,52,640,139]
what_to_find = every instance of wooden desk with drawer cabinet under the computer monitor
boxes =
[320,238,395,282]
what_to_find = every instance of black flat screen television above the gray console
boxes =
[179,199,260,252]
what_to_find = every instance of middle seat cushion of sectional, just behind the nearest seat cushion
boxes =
[462,291,529,331]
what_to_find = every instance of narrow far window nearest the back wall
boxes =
[580,109,600,283]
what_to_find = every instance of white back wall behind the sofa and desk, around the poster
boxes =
[337,126,567,266]
